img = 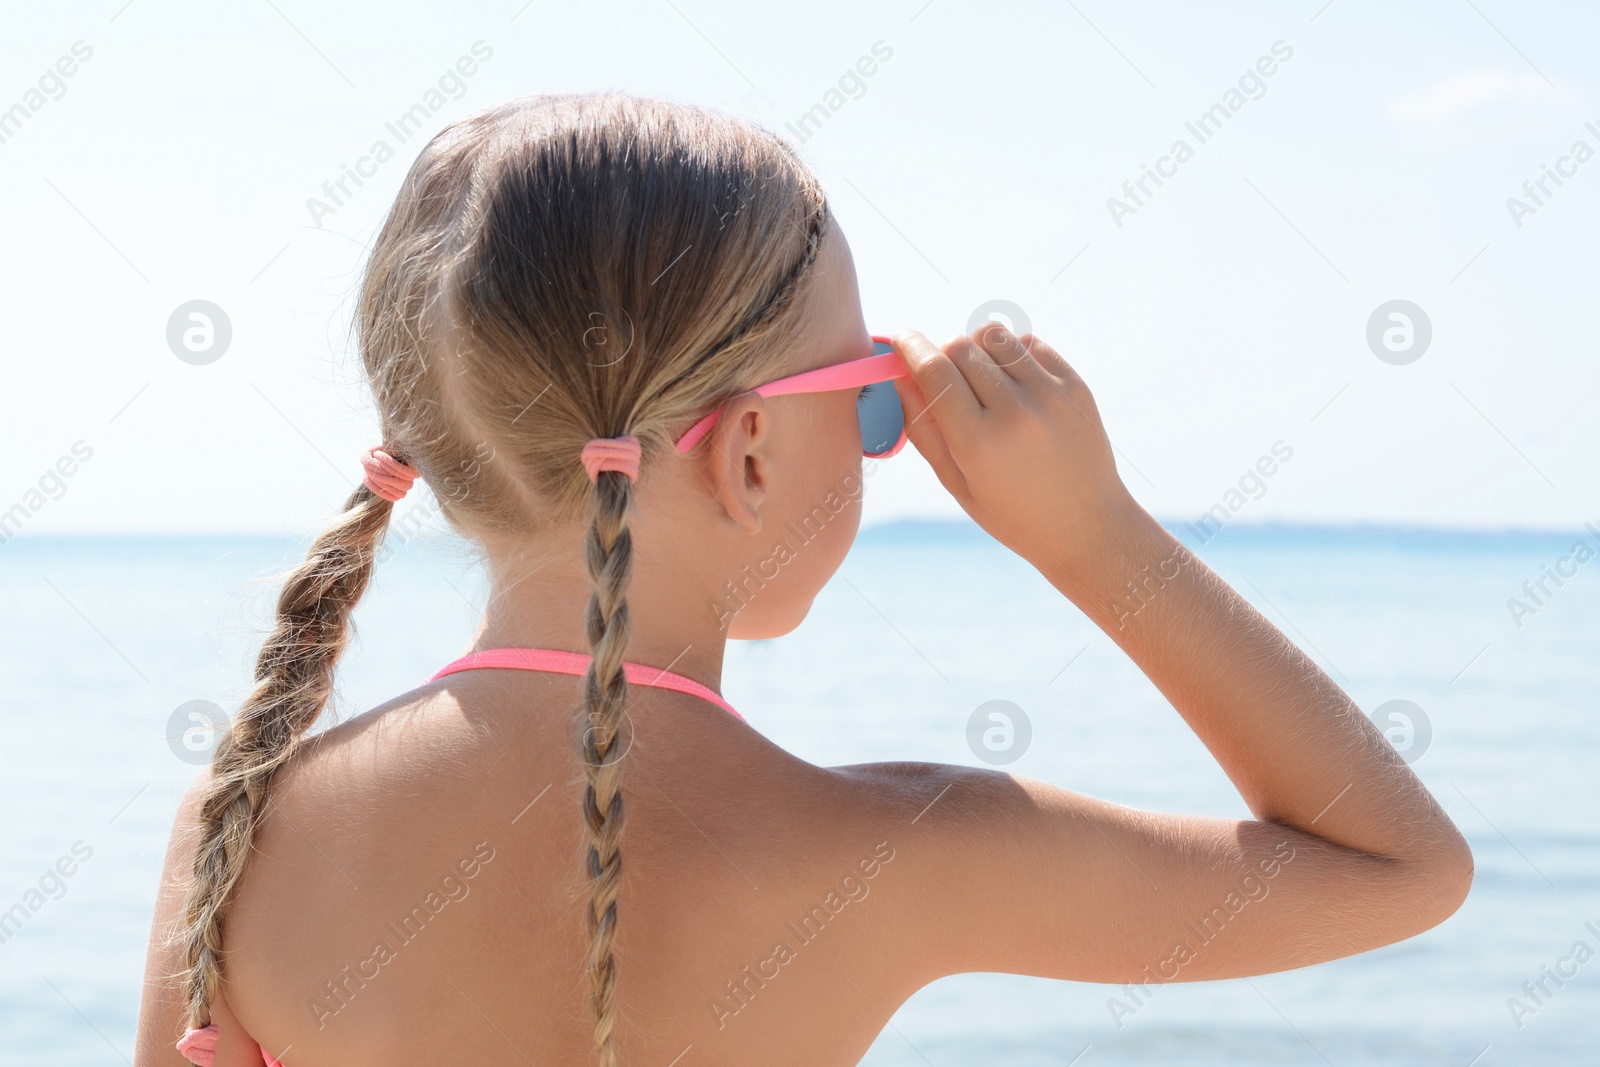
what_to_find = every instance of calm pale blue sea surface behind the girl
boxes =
[0,523,1600,1067]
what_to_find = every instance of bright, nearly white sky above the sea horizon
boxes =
[0,0,1600,534]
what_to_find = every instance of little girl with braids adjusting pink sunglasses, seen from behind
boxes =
[138,93,1472,1067]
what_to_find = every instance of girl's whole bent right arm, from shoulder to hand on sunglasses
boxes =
[840,325,1472,982]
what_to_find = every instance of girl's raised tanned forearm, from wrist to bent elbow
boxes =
[1042,492,1472,883]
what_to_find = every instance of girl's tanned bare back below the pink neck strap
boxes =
[147,672,934,1065]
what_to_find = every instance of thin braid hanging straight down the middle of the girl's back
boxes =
[581,470,634,1067]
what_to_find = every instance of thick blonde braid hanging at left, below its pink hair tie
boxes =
[181,485,394,1027]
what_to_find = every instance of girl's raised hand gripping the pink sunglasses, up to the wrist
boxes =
[893,322,1136,571]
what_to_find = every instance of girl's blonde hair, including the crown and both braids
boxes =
[182,93,829,1067]
